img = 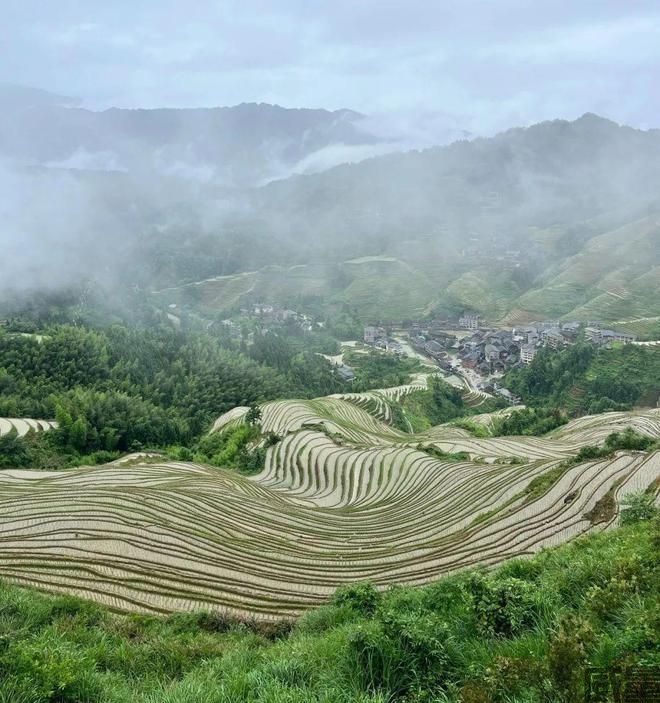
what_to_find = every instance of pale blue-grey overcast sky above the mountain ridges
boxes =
[0,0,660,133]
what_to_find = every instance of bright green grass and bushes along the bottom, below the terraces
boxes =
[0,512,660,703]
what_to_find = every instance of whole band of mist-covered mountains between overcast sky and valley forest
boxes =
[0,90,660,320]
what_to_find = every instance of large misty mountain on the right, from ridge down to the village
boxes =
[152,115,660,324]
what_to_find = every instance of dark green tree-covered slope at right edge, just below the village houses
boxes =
[504,342,660,414]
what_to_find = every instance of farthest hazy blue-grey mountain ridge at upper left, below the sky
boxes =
[0,92,383,187]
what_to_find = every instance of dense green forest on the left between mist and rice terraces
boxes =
[0,321,356,468]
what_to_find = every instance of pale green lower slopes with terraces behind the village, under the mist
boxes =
[158,216,660,326]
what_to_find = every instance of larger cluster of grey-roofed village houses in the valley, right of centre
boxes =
[364,314,636,377]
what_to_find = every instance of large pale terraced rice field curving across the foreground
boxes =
[0,397,660,619]
